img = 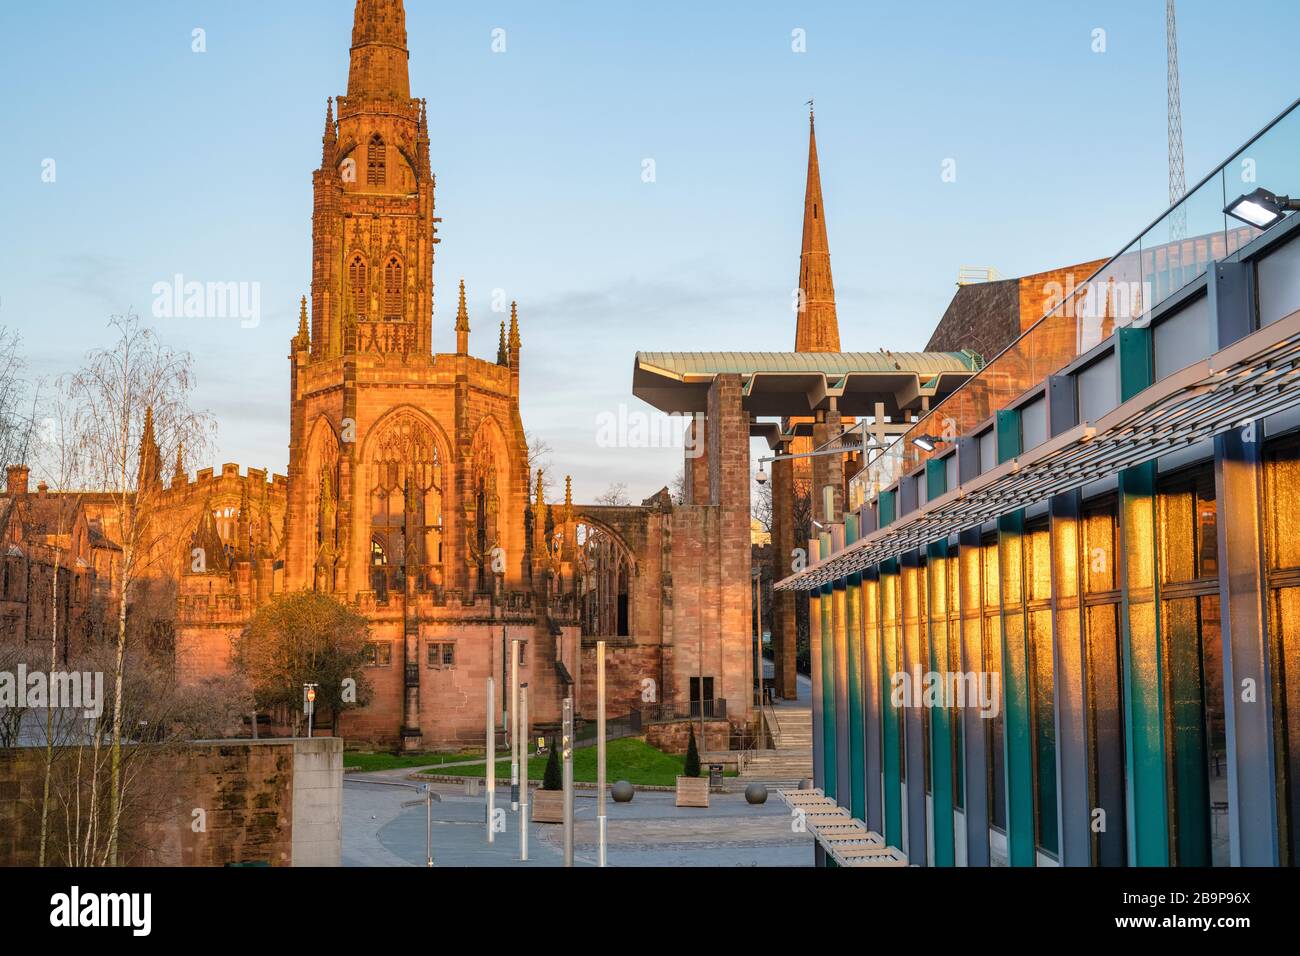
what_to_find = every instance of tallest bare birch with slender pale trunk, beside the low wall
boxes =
[65,312,215,865]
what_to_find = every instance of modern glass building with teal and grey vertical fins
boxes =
[777,97,1300,866]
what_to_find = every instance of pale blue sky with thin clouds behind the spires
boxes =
[0,0,1300,499]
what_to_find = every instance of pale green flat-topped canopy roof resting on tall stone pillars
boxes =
[632,351,982,416]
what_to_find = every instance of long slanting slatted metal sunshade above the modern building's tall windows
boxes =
[775,312,1300,591]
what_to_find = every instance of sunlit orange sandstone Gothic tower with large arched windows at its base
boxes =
[283,0,533,748]
